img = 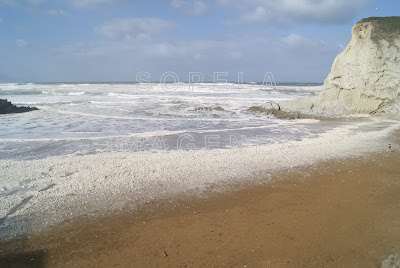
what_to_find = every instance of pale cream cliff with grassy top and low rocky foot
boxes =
[260,17,400,120]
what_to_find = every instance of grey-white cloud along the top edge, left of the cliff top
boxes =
[217,0,373,24]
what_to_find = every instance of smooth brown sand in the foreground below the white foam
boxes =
[0,143,400,267]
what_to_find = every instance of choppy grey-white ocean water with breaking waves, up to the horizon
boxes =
[0,83,324,159]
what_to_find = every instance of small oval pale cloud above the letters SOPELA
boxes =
[94,18,176,41]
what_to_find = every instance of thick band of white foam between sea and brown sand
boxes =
[0,118,399,239]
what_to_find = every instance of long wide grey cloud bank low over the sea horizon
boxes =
[54,32,341,82]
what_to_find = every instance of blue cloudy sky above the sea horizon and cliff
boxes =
[0,0,400,82]
